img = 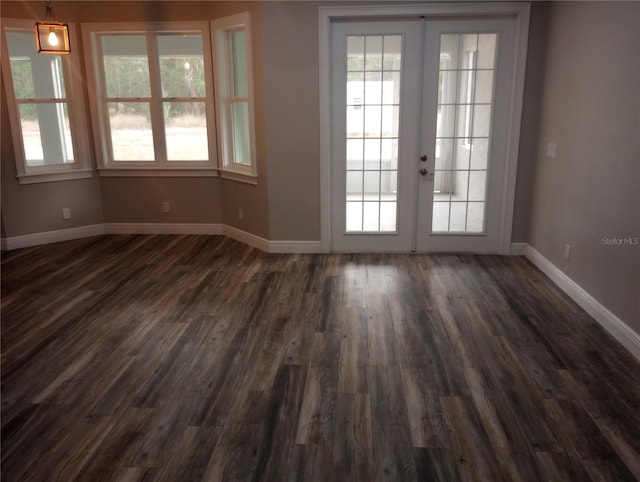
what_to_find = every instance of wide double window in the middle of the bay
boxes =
[83,22,217,175]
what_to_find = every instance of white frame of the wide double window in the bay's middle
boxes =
[81,21,218,177]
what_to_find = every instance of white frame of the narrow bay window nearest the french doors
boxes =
[211,12,258,184]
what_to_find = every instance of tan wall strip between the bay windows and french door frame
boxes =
[262,2,320,241]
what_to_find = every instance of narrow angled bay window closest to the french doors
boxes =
[212,13,256,183]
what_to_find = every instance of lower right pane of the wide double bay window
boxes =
[163,102,209,161]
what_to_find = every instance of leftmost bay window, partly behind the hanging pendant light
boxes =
[2,19,92,183]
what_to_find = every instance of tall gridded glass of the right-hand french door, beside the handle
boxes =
[431,33,497,233]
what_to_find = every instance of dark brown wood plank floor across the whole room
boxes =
[1,236,640,482]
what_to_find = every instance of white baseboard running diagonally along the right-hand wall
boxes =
[524,244,640,360]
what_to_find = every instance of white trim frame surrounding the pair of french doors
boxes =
[318,2,531,254]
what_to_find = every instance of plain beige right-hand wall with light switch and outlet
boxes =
[529,2,640,333]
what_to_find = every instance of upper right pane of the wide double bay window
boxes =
[157,35,206,97]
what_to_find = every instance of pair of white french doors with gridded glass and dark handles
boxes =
[330,17,515,252]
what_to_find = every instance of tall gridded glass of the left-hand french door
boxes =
[345,35,402,233]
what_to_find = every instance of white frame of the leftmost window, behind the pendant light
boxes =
[2,17,93,184]
